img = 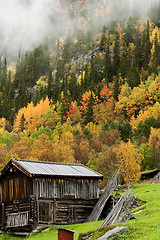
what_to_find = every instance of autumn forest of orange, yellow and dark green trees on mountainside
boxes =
[0,1,160,186]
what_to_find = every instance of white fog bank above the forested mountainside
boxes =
[0,0,156,59]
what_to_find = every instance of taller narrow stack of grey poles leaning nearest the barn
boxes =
[86,170,119,222]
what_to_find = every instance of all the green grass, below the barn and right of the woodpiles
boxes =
[0,183,160,240]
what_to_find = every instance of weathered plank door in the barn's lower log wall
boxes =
[38,200,53,224]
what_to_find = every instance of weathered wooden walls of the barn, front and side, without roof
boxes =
[0,167,99,228]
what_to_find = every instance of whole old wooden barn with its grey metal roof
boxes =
[0,159,103,229]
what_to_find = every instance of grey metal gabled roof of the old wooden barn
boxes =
[1,158,103,178]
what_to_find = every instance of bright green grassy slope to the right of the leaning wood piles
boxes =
[116,183,160,240]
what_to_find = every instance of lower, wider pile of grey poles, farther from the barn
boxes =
[101,189,136,227]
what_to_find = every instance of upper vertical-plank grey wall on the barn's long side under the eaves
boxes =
[33,179,99,199]
